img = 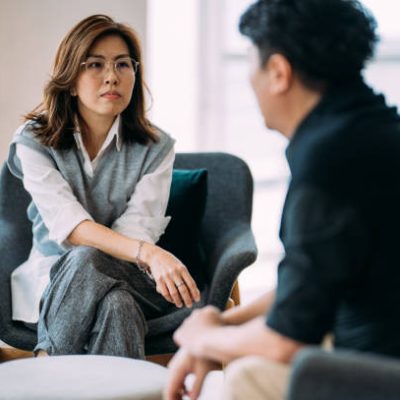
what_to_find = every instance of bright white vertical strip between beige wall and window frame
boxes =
[147,0,199,152]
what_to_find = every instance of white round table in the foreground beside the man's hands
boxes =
[0,355,168,400]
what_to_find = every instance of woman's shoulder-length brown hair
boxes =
[25,14,158,149]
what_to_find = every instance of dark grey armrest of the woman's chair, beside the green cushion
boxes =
[207,223,257,309]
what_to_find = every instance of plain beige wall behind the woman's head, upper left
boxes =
[0,0,147,162]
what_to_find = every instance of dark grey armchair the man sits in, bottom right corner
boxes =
[288,348,400,400]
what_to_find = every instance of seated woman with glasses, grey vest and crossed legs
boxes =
[8,15,200,358]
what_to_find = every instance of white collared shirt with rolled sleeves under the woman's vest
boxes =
[11,117,175,323]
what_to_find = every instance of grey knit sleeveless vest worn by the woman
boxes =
[7,122,174,256]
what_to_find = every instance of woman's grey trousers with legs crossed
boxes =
[34,246,176,359]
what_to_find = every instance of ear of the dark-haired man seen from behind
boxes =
[266,53,293,94]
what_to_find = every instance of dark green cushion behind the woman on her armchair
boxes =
[158,169,207,289]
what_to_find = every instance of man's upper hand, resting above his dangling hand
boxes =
[174,306,223,358]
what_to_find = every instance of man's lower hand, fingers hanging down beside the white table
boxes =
[164,349,219,400]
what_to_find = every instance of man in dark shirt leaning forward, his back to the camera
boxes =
[166,0,400,399]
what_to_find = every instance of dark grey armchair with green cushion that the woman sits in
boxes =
[0,153,257,355]
